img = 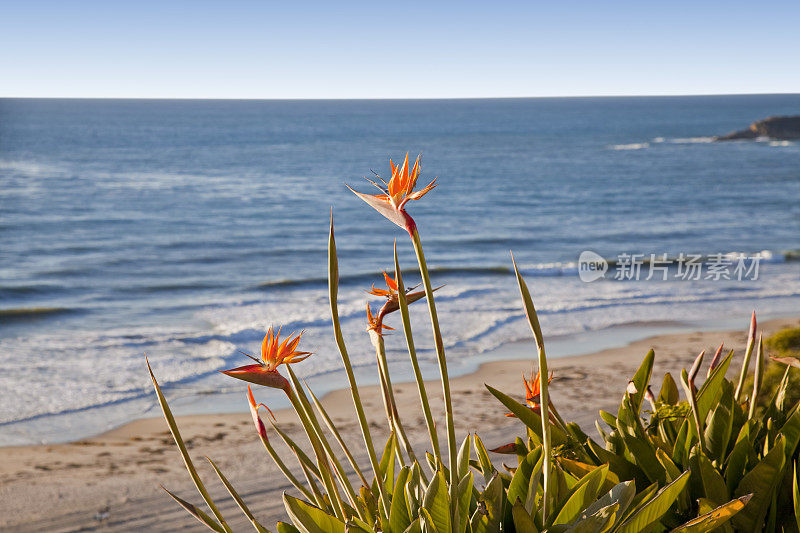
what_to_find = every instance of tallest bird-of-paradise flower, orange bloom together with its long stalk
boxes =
[348,153,458,519]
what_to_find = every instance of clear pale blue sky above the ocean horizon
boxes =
[0,0,800,98]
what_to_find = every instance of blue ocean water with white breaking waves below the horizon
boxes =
[0,95,800,444]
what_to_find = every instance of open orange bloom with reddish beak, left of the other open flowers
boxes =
[220,327,311,389]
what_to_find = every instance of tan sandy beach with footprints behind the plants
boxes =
[0,318,800,532]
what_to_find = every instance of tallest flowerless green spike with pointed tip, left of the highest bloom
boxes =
[328,216,389,518]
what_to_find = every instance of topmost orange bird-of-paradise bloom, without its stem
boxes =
[347,152,436,234]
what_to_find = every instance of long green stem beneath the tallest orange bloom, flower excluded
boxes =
[411,227,458,519]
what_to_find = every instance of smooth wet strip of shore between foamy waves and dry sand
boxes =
[6,312,793,449]
